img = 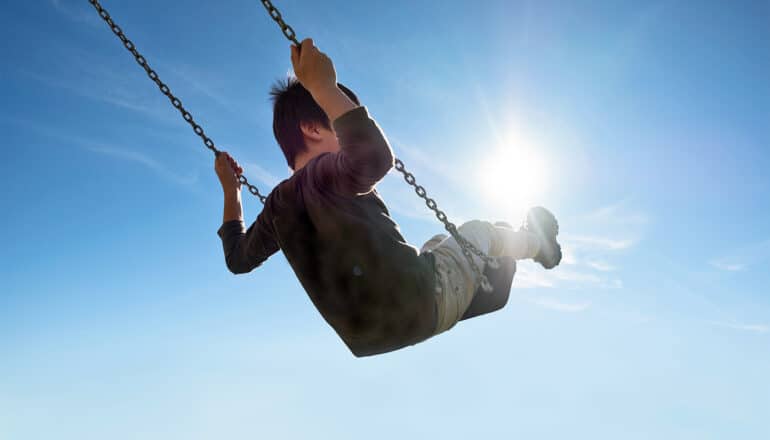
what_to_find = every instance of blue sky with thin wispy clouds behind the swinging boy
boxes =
[0,0,770,440]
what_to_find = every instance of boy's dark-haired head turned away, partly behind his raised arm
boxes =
[270,77,360,171]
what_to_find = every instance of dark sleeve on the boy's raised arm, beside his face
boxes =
[308,107,394,196]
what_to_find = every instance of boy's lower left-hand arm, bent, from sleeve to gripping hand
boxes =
[215,152,279,274]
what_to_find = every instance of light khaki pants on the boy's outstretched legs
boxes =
[420,220,540,334]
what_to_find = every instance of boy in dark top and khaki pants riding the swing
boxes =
[215,39,561,356]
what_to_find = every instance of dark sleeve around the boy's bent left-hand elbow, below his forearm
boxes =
[217,210,280,274]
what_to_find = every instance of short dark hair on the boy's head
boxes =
[270,76,360,170]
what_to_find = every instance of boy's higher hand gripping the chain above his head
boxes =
[291,38,337,95]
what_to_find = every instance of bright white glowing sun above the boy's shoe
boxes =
[478,146,548,214]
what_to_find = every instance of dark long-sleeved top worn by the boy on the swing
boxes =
[219,107,436,356]
